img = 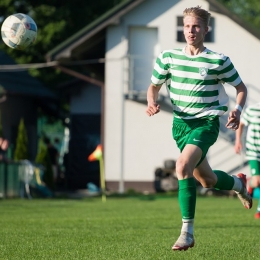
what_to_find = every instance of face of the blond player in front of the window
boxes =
[183,16,208,47]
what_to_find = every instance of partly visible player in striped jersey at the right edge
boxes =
[235,102,260,219]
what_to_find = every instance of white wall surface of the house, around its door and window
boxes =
[105,0,260,185]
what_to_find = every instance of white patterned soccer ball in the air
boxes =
[1,13,37,50]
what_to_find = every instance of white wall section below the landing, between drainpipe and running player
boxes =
[123,101,179,181]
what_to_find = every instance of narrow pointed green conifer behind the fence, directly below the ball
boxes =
[14,118,29,161]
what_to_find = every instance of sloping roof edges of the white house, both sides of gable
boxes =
[46,0,260,61]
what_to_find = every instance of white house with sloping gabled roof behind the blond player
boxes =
[47,0,260,192]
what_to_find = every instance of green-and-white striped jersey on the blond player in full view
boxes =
[151,48,241,119]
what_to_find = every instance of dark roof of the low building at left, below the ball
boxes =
[0,51,57,99]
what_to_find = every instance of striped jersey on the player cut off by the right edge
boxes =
[241,102,260,161]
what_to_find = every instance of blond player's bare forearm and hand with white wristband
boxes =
[226,82,247,131]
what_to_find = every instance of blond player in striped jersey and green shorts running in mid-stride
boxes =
[146,6,252,250]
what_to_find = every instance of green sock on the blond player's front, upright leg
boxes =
[178,178,197,219]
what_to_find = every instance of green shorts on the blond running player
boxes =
[172,117,219,165]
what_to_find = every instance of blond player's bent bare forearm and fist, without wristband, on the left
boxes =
[146,84,161,116]
